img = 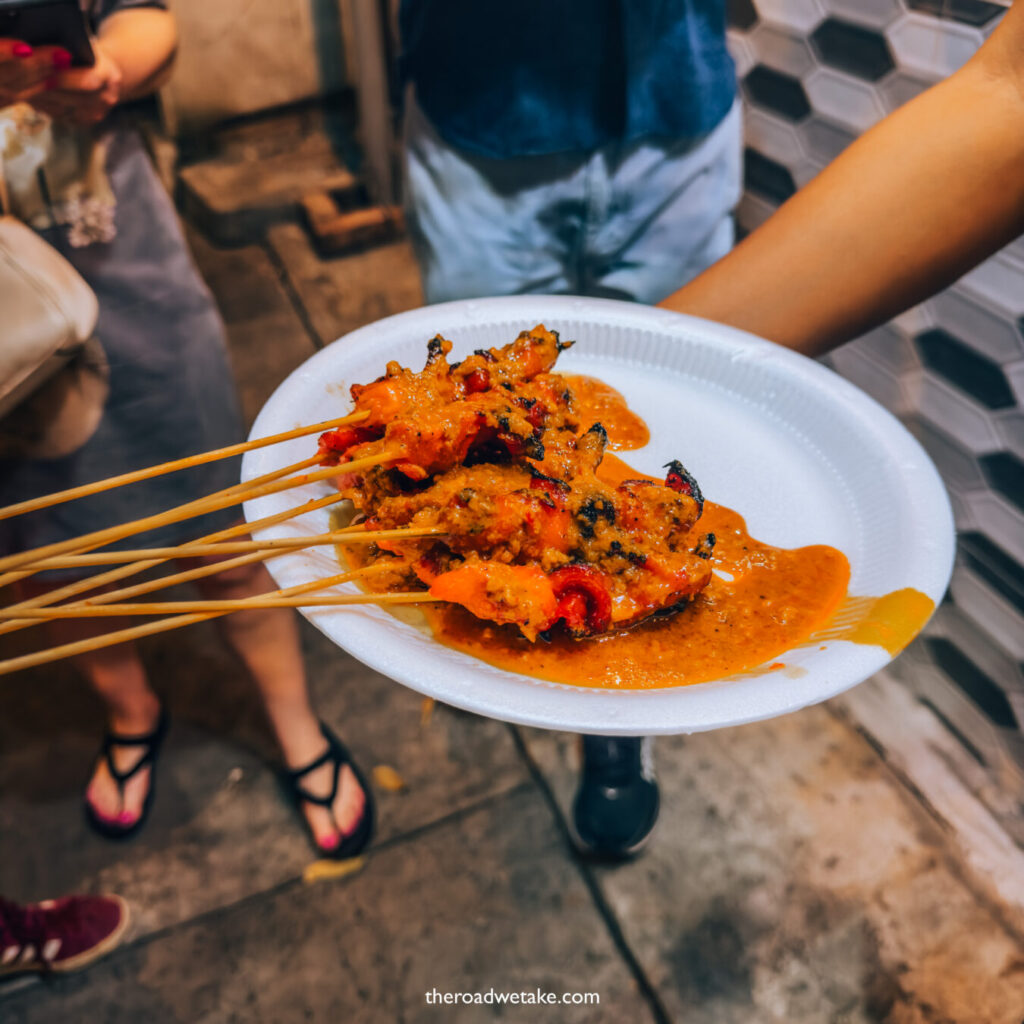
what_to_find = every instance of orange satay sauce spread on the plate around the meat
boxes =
[342,375,935,689]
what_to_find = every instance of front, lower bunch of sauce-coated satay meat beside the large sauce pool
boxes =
[354,415,711,639]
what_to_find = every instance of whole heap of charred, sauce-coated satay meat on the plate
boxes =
[321,327,714,640]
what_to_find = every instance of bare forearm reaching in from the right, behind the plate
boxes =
[660,0,1024,354]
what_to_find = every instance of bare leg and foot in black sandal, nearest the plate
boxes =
[186,562,366,851]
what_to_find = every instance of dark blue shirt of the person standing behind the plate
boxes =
[400,0,736,158]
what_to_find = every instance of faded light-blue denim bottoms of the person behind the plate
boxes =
[404,90,741,303]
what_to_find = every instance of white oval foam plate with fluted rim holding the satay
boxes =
[243,296,953,735]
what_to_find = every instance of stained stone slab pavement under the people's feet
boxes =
[0,225,1024,1024]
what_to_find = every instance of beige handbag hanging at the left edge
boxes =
[0,150,106,458]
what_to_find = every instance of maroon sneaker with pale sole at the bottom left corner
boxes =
[0,896,129,978]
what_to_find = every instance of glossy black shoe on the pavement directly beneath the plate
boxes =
[570,736,659,860]
